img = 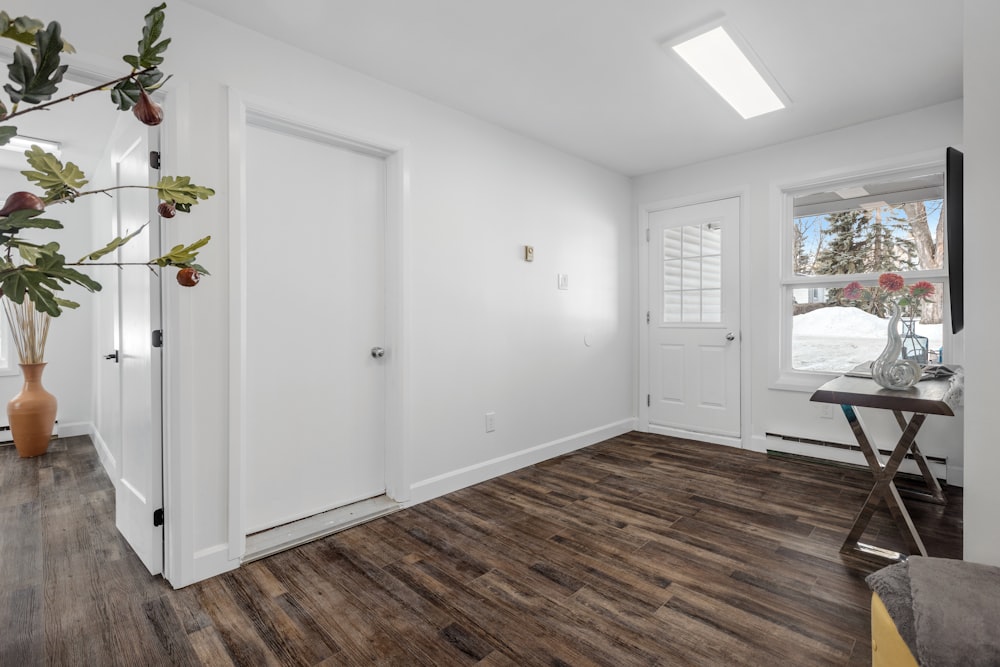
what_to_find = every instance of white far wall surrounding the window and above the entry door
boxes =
[634,102,962,483]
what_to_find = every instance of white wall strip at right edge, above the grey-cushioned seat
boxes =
[964,0,1000,565]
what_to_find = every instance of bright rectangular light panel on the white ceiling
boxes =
[665,23,788,118]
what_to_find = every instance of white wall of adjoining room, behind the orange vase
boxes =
[0,170,93,436]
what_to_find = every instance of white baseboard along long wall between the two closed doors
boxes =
[405,419,636,507]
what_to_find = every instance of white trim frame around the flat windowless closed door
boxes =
[228,88,410,561]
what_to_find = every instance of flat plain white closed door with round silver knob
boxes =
[243,124,393,534]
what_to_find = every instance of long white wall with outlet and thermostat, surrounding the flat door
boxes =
[7,0,634,585]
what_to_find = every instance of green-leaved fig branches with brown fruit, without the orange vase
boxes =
[0,3,215,317]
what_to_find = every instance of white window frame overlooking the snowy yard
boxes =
[770,160,961,391]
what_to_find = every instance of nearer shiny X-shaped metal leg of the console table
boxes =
[840,405,927,560]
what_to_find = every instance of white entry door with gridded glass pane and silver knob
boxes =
[648,198,740,437]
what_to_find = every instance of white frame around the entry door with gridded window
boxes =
[635,186,752,447]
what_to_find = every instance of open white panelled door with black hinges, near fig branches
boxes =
[113,129,163,574]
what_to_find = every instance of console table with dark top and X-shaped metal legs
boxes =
[810,374,961,561]
